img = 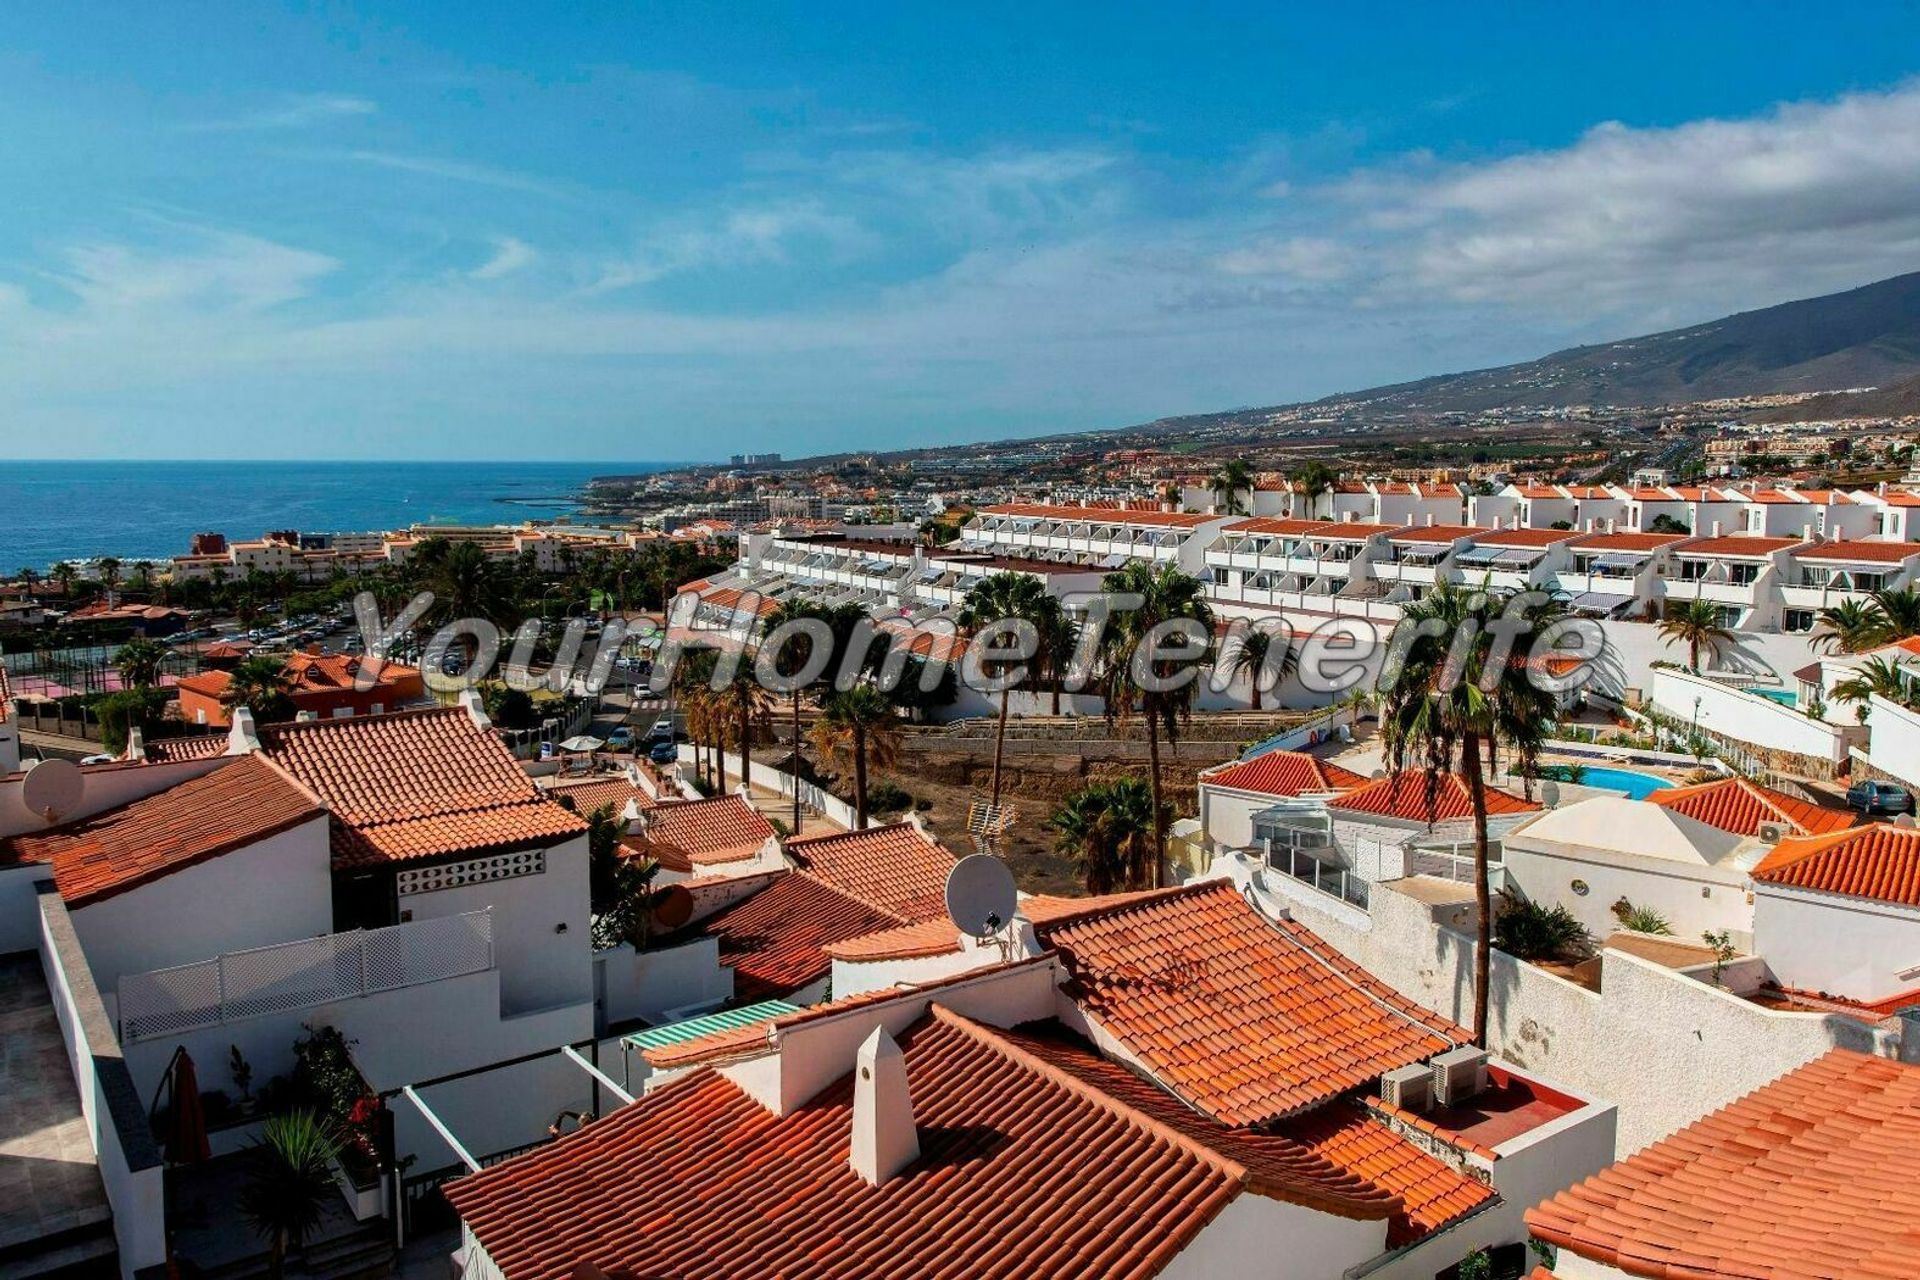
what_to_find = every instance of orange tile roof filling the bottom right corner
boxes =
[1526,1050,1920,1280]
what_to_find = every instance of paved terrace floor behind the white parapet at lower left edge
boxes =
[0,952,109,1249]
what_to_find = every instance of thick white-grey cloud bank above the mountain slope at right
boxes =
[1346,84,1920,315]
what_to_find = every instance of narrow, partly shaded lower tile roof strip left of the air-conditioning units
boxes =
[1000,1023,1494,1249]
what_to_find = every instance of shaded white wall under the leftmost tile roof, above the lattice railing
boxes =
[73,814,334,1007]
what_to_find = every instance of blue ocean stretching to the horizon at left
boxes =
[0,461,674,576]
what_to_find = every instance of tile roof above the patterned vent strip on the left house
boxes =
[259,706,586,867]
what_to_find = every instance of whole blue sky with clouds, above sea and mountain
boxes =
[0,2,1920,461]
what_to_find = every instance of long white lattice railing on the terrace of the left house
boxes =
[119,910,493,1042]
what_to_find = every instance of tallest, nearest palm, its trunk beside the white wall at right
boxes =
[1380,583,1559,1046]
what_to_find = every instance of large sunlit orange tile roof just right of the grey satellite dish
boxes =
[1037,881,1467,1125]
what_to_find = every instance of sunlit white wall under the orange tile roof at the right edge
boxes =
[1753,881,1920,1004]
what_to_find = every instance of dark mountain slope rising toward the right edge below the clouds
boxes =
[1315,273,1920,413]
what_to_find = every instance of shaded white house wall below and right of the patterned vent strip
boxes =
[412,835,593,1013]
